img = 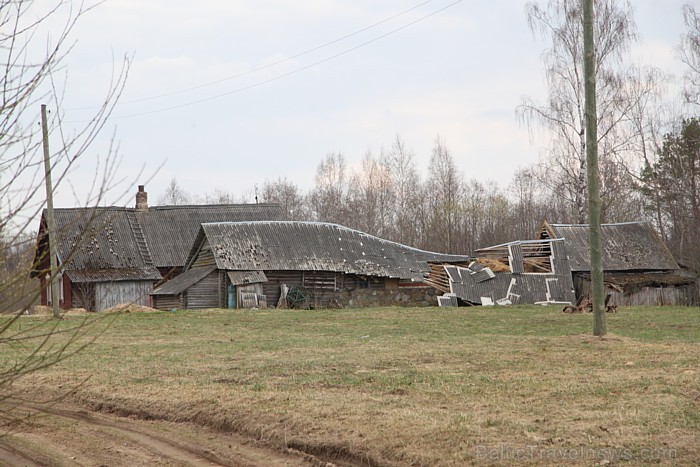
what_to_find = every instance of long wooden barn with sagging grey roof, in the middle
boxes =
[152,222,467,310]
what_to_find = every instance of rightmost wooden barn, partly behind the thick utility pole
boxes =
[539,221,696,305]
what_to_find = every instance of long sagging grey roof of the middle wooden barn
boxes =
[187,221,467,282]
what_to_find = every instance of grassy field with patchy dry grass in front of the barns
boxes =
[0,306,700,465]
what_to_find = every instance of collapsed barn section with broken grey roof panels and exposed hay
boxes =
[428,239,574,306]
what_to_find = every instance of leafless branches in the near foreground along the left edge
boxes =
[0,0,129,419]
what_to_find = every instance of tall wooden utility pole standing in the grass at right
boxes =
[583,0,607,336]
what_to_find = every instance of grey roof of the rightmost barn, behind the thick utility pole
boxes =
[539,221,679,272]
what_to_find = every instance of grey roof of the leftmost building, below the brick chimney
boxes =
[34,204,282,280]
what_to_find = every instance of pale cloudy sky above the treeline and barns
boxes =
[28,0,687,211]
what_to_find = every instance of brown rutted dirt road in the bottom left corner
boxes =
[0,402,318,466]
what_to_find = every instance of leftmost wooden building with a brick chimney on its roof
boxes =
[32,186,282,311]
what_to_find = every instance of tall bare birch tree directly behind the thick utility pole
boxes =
[517,0,663,223]
